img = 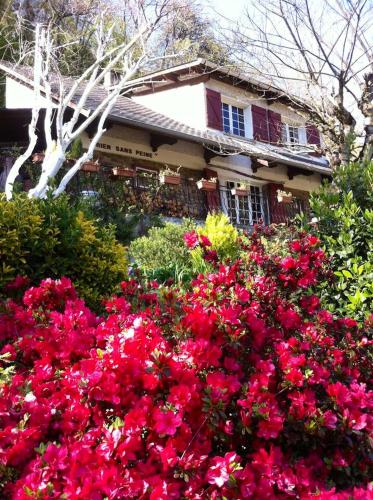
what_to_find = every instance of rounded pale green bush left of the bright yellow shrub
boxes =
[129,220,194,282]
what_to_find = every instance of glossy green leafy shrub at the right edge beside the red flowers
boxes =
[300,163,373,319]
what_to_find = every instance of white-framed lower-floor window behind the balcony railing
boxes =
[222,181,263,226]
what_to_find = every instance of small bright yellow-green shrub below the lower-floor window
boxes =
[197,213,239,261]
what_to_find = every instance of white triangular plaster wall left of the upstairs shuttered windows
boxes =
[133,83,206,130]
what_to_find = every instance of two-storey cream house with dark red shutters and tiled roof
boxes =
[0,59,331,227]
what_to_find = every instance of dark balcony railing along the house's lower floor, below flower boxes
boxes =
[70,171,303,229]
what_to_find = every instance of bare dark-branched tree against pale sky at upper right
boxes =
[230,0,373,164]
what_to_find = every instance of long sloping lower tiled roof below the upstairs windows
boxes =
[0,61,331,174]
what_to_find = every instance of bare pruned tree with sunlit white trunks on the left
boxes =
[5,0,186,199]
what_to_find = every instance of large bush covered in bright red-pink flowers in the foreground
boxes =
[0,229,373,500]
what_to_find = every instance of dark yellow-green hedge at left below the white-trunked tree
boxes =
[0,194,127,308]
